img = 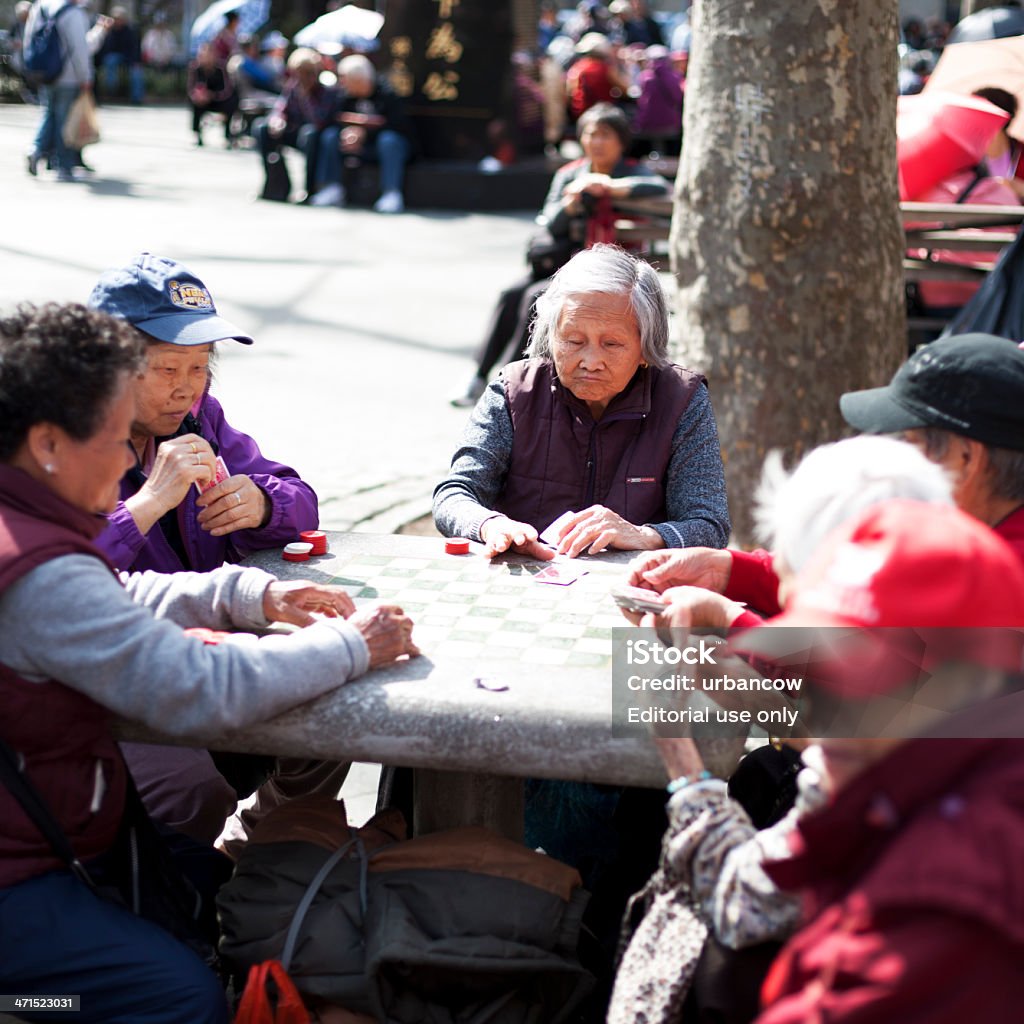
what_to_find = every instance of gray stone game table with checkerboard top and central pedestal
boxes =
[121,534,665,838]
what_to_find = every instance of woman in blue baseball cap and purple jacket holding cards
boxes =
[89,253,318,572]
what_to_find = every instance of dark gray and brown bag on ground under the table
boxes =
[217,796,593,1024]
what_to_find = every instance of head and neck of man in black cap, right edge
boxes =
[840,334,1024,560]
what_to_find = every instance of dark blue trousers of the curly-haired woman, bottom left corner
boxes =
[0,870,228,1024]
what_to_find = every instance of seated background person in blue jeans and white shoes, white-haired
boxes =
[311,53,412,213]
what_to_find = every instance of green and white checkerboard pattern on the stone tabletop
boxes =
[323,554,626,668]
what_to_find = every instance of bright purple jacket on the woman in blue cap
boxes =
[96,394,319,572]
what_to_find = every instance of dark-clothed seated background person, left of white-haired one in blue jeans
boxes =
[253,47,338,198]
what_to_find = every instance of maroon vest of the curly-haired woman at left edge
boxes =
[0,465,126,887]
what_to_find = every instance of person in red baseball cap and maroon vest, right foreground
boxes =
[608,501,1024,1024]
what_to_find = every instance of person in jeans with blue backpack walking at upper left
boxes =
[25,0,92,181]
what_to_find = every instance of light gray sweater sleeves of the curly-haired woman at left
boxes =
[0,555,370,734]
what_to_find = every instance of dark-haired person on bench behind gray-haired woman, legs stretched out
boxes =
[452,103,670,407]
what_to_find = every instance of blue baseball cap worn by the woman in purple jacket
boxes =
[89,253,253,345]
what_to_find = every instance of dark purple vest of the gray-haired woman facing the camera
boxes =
[497,359,705,529]
